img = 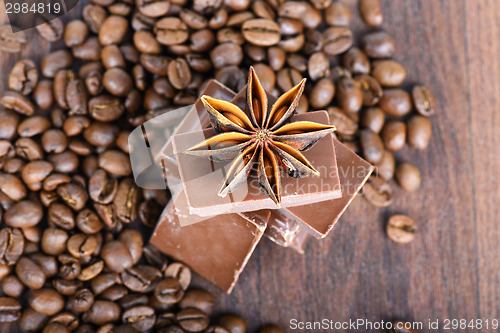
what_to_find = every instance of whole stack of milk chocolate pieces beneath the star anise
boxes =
[146,76,373,293]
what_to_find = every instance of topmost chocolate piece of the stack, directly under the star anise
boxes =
[173,111,342,216]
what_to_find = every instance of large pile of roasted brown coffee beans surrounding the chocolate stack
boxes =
[0,0,435,333]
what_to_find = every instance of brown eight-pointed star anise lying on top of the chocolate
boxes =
[186,67,336,206]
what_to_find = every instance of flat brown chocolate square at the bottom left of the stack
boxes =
[149,188,270,293]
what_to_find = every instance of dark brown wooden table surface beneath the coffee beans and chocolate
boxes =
[0,0,500,332]
